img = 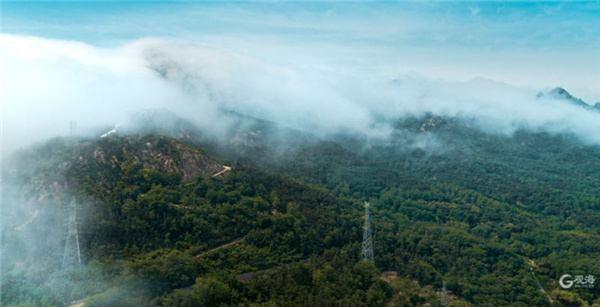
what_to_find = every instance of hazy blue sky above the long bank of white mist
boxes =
[2,1,600,96]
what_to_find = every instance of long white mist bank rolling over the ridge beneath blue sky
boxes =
[0,35,600,158]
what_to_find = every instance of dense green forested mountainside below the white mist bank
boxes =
[0,112,600,306]
